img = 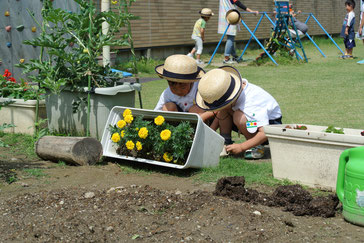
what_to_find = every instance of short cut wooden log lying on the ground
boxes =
[35,136,102,165]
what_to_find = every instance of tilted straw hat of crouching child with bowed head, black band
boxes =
[196,66,243,111]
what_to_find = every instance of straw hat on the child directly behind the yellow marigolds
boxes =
[155,55,205,83]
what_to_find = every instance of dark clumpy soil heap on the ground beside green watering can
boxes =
[214,176,339,218]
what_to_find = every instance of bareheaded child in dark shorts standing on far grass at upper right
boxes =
[340,0,355,59]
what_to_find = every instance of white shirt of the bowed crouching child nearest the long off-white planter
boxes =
[232,79,282,127]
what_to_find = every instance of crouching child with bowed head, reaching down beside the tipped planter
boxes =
[196,66,282,159]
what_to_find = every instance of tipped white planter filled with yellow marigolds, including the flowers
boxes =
[101,106,224,169]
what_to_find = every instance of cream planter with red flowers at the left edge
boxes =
[0,69,46,135]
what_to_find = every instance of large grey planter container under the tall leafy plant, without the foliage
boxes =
[46,83,141,138]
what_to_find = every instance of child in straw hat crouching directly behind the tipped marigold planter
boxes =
[154,55,217,124]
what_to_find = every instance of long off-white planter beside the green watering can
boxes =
[264,124,364,191]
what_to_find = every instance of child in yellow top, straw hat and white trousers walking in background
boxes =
[187,8,214,64]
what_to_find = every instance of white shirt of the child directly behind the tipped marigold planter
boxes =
[154,82,198,112]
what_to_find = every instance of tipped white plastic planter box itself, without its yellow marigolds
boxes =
[101,106,224,169]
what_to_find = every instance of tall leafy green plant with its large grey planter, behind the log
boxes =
[19,0,140,137]
